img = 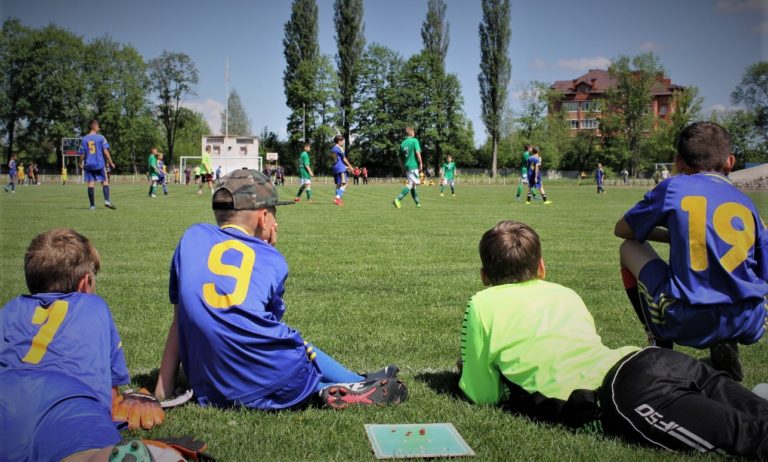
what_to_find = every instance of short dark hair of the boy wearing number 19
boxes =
[677,122,731,171]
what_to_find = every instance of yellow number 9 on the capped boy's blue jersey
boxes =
[203,240,256,308]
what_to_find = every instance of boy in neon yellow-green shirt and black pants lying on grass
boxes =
[459,221,768,460]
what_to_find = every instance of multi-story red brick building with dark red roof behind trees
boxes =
[550,69,684,134]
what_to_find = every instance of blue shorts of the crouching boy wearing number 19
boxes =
[637,259,768,348]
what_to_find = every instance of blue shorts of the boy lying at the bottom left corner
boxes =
[0,370,120,460]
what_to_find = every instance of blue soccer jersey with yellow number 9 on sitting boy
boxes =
[169,224,320,409]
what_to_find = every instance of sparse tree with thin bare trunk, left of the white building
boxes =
[148,51,198,164]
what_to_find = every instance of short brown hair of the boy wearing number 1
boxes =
[24,228,101,294]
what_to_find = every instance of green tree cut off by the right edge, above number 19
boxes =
[731,61,768,151]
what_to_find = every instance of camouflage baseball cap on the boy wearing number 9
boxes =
[213,168,293,210]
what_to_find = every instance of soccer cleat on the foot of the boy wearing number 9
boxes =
[320,379,408,409]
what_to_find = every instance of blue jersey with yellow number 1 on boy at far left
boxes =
[0,292,130,409]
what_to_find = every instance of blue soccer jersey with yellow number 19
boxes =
[624,173,768,305]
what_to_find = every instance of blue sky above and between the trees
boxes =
[0,0,768,142]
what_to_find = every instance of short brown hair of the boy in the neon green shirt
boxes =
[480,220,541,286]
